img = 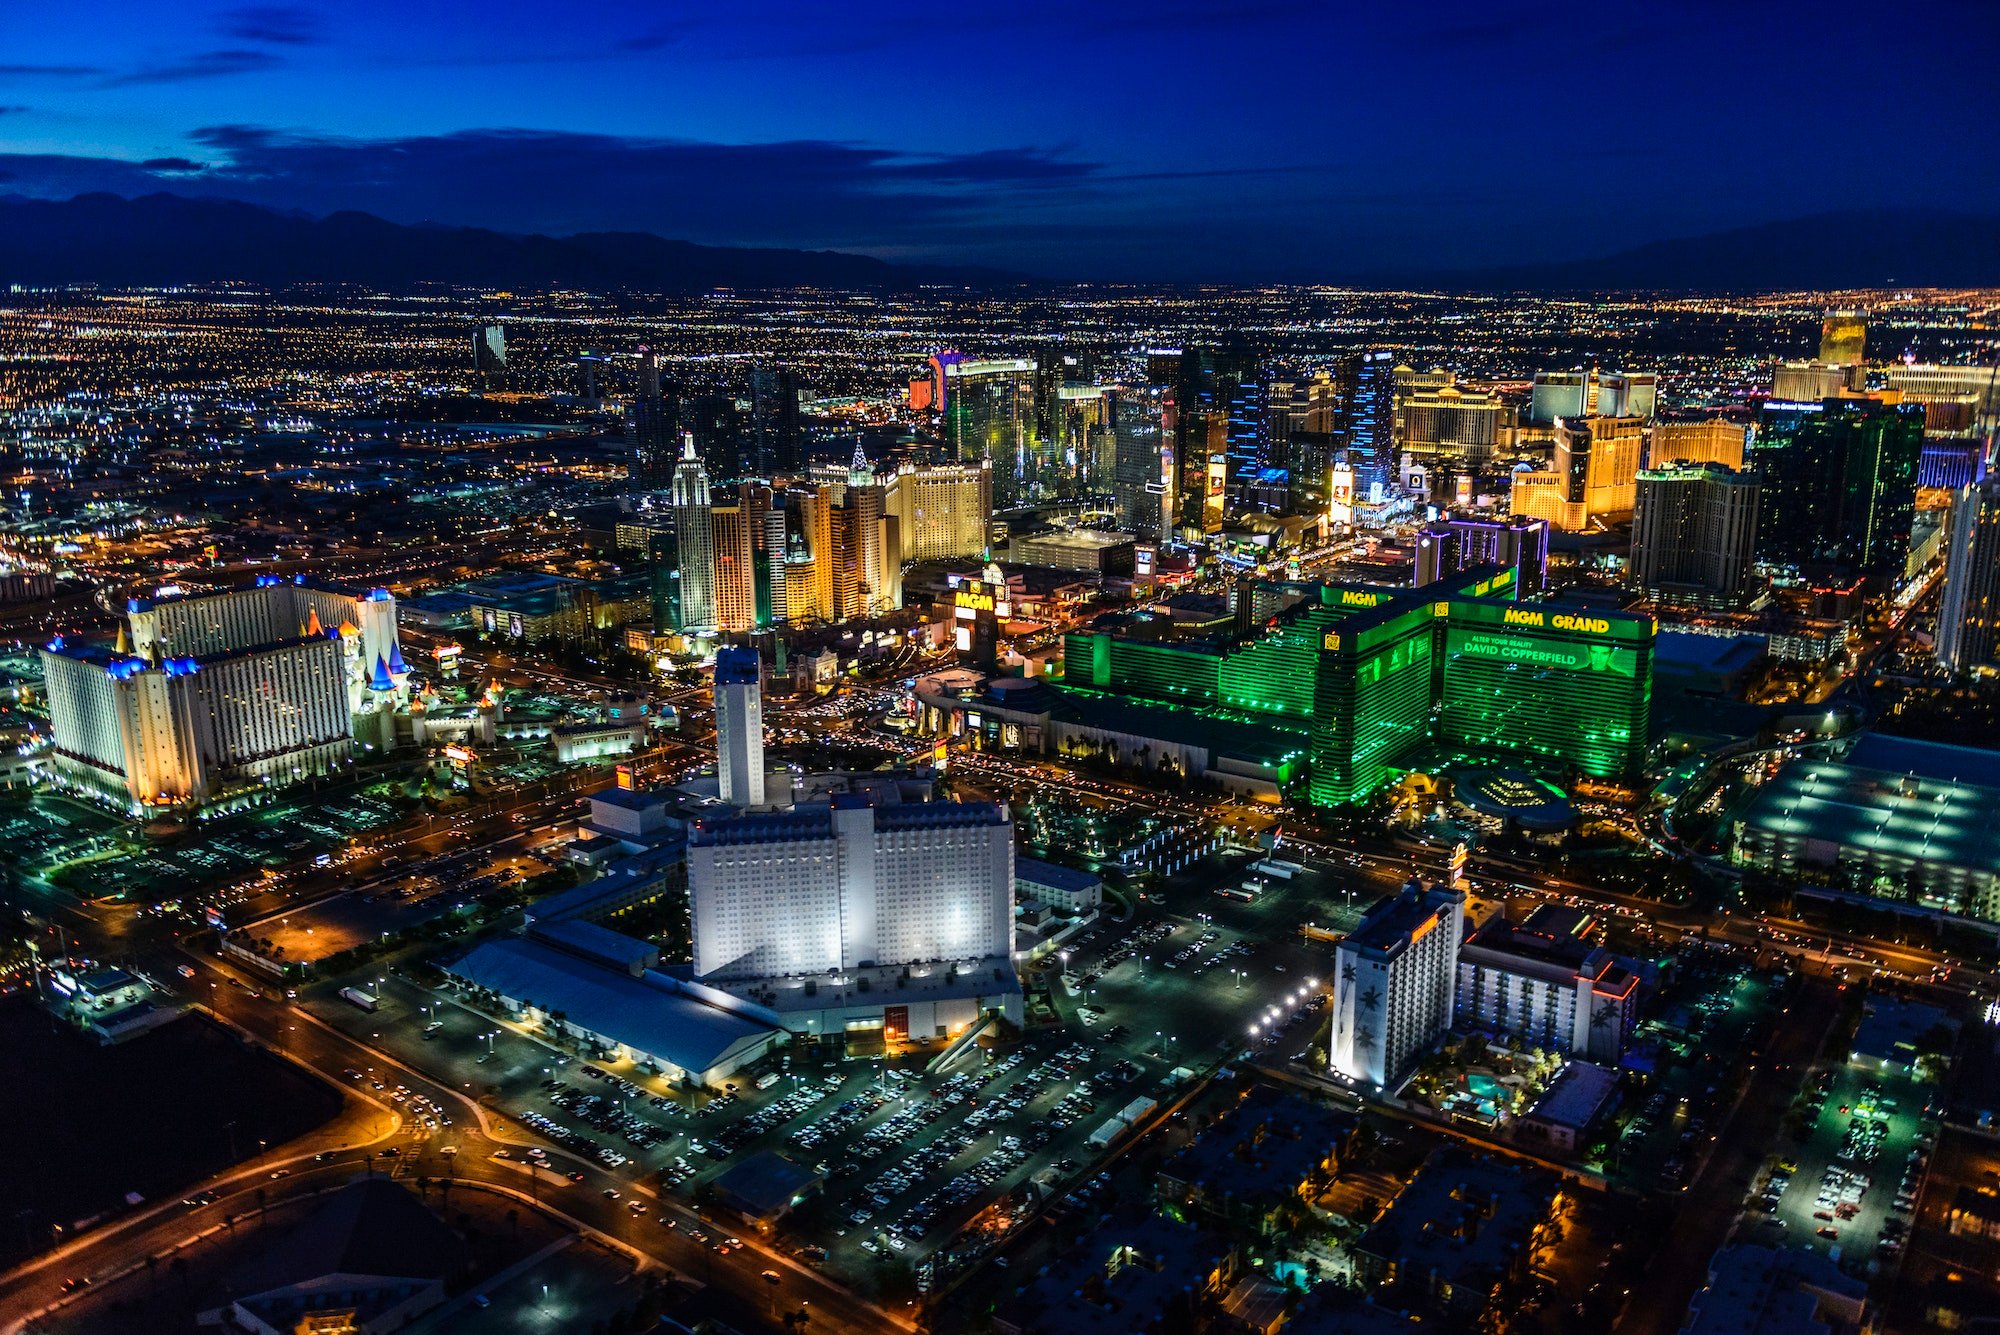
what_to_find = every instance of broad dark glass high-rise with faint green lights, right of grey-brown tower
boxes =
[1750,400,1924,574]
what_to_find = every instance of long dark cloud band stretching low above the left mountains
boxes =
[0,124,1104,248]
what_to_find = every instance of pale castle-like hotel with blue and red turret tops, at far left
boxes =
[42,576,408,813]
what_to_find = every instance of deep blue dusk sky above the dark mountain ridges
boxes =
[0,0,2000,280]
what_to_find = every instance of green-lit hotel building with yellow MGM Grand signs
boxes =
[1064,568,1654,805]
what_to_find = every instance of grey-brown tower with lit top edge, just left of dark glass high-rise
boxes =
[1632,464,1760,606]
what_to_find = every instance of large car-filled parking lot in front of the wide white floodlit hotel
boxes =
[296,855,1348,1291]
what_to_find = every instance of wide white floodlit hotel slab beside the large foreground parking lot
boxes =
[688,793,1014,979]
